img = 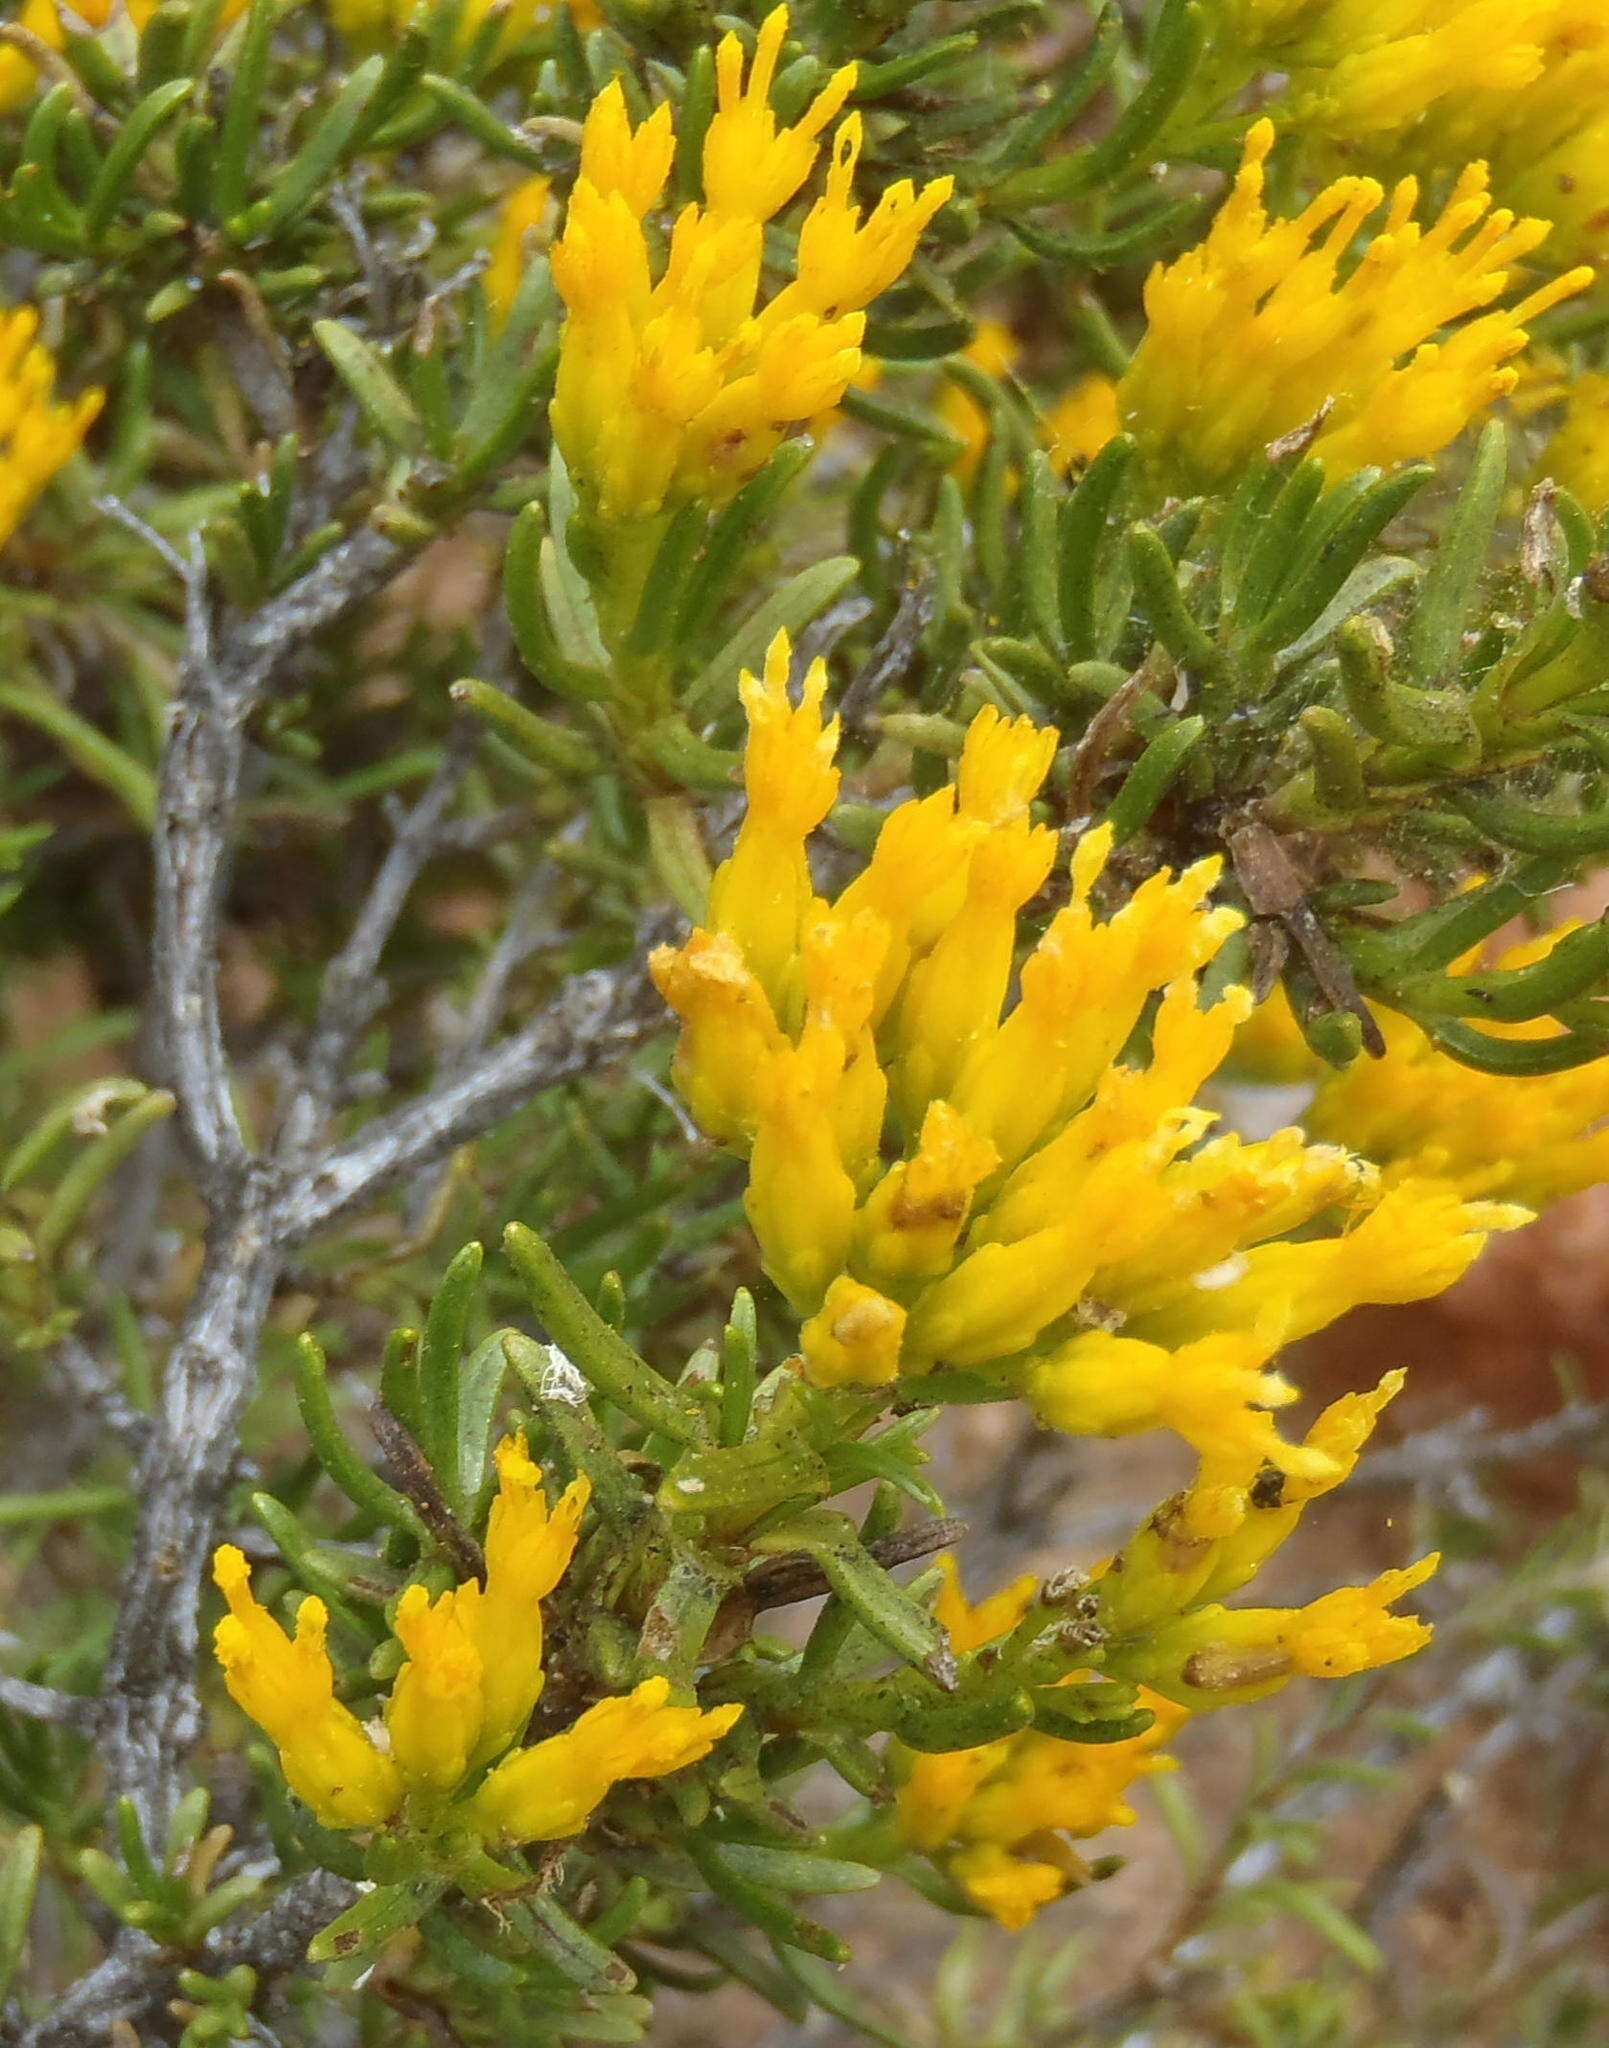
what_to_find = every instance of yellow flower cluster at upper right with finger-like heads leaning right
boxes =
[1118,121,1591,489]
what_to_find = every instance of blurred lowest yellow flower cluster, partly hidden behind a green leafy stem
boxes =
[895,1556,1187,1929]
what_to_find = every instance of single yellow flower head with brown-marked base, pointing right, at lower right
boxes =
[1105,1552,1441,1708]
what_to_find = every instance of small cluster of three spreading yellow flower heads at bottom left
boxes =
[213,1436,741,1843]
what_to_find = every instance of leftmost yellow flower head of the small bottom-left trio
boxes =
[213,1544,403,1827]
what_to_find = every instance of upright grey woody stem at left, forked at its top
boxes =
[102,528,401,1833]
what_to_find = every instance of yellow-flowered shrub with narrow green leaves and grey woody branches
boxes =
[0,0,1609,2048]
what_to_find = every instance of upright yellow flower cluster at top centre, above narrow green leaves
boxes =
[553,8,952,520]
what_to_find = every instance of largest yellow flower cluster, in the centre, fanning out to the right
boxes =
[653,637,1527,1470]
